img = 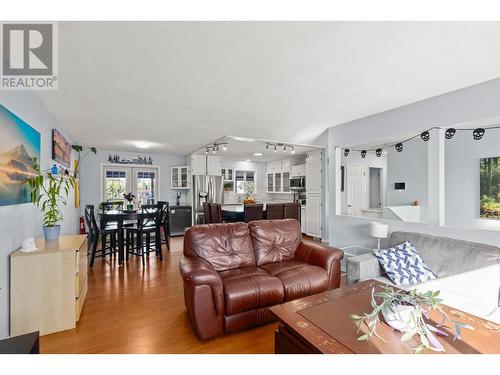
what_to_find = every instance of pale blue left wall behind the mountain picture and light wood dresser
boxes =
[0,91,79,339]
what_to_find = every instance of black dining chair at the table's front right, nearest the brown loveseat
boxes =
[125,204,163,266]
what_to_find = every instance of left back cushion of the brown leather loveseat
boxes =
[184,223,255,271]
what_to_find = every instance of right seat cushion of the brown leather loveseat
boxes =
[261,260,328,301]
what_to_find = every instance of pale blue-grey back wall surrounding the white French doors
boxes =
[80,150,186,209]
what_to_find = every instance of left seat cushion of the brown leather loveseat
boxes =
[220,267,284,316]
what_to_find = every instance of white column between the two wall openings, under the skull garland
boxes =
[427,129,445,226]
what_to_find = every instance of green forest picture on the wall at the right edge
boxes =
[480,157,500,219]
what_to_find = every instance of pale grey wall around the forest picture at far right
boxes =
[445,125,500,231]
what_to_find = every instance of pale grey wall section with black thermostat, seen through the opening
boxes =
[386,138,429,223]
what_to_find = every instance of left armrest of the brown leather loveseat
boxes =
[179,256,224,315]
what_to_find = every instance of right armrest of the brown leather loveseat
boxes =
[295,242,344,289]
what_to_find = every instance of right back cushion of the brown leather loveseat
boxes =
[248,219,302,266]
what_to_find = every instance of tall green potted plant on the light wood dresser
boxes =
[27,159,75,241]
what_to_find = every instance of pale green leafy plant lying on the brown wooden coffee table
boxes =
[350,285,474,353]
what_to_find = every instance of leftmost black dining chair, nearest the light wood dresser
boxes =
[85,204,118,268]
